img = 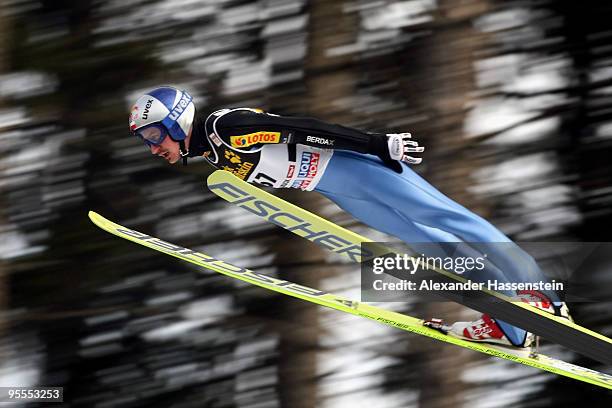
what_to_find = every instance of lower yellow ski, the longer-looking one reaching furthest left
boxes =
[89,211,612,389]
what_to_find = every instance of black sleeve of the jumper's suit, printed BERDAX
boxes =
[215,109,380,153]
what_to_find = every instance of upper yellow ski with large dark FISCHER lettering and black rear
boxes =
[207,170,612,365]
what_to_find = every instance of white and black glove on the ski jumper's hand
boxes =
[372,133,425,173]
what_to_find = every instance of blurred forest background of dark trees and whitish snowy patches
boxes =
[0,0,612,408]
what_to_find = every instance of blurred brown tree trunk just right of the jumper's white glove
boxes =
[411,0,489,407]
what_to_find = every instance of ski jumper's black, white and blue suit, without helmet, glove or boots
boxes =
[194,108,558,345]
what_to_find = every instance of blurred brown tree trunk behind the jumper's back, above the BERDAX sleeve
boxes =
[270,0,357,408]
